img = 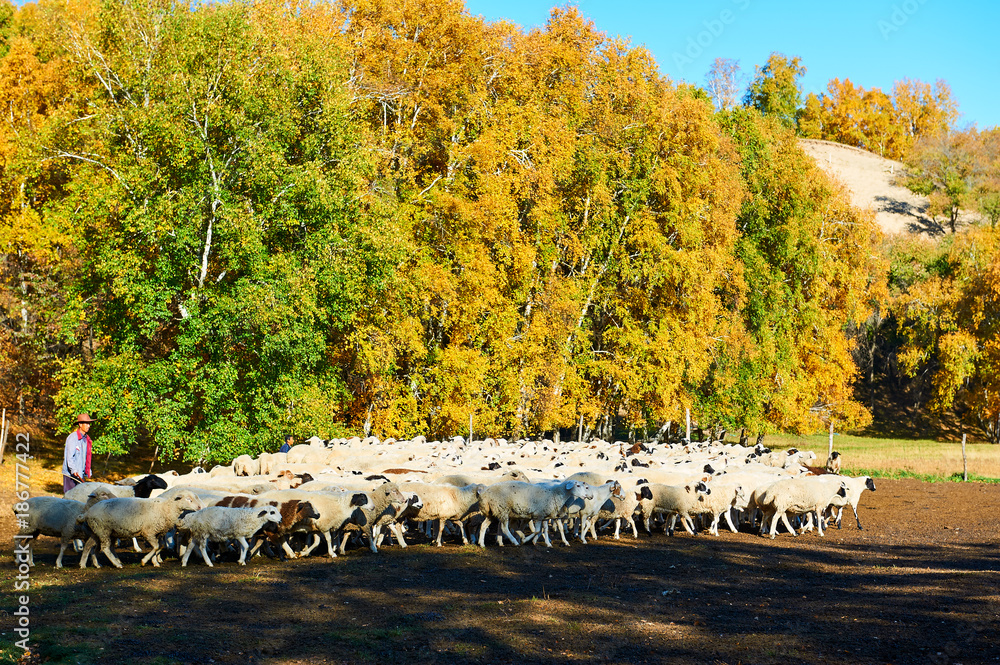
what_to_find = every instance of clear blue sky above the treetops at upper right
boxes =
[466,0,1000,129]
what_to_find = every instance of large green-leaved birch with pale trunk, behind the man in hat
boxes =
[42,4,402,461]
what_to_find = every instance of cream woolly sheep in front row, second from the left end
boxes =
[76,492,202,568]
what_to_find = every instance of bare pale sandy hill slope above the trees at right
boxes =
[799,139,944,235]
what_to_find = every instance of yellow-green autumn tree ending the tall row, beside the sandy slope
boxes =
[707,109,885,431]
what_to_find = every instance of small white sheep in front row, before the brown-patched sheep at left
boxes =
[177,506,281,567]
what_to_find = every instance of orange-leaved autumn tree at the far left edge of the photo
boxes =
[0,3,88,424]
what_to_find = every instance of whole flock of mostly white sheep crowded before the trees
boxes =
[21,437,875,568]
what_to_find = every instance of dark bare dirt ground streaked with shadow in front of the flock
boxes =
[0,480,1000,665]
